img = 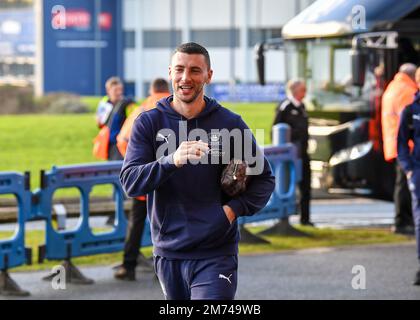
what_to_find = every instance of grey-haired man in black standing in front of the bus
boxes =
[273,79,314,227]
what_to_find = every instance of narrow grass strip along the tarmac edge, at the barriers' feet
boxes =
[0,226,410,271]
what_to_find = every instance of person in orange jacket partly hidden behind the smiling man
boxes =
[114,78,171,280]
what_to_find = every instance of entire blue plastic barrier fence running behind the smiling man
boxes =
[0,124,301,295]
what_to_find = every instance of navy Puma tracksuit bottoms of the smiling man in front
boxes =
[154,255,238,300]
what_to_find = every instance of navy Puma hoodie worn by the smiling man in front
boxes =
[120,96,275,259]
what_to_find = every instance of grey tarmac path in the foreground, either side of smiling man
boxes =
[0,243,420,300]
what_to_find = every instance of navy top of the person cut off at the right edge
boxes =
[398,91,420,172]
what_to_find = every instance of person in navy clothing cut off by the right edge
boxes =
[398,68,420,286]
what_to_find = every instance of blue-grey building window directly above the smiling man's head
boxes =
[191,29,239,48]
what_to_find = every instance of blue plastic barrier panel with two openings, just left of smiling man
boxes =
[32,161,151,260]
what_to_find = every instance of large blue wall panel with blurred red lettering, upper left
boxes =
[43,0,122,95]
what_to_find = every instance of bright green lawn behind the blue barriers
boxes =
[0,101,275,195]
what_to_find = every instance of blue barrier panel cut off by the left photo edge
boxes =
[0,172,32,295]
